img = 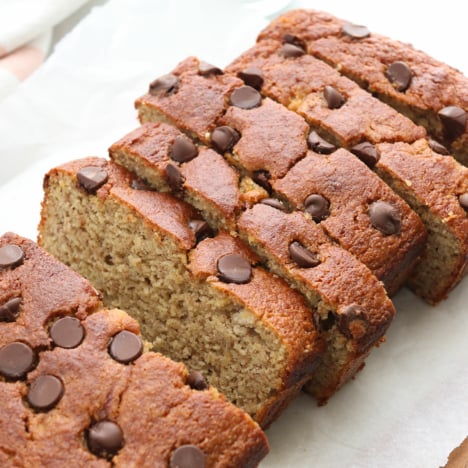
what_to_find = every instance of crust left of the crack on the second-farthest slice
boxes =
[226,40,426,146]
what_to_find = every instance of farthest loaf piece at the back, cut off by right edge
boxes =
[259,10,468,165]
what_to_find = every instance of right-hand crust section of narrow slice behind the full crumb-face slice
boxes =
[239,204,395,352]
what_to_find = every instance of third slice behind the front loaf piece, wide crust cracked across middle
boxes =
[136,58,425,294]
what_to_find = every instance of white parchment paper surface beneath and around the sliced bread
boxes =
[0,0,468,468]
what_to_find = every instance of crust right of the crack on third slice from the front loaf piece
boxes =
[273,149,426,294]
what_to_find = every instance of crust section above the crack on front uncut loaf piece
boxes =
[0,233,102,347]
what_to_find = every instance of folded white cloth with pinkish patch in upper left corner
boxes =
[0,0,89,100]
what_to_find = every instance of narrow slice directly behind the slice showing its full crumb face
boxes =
[110,122,394,403]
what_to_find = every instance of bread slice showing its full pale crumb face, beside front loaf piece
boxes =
[39,158,323,427]
